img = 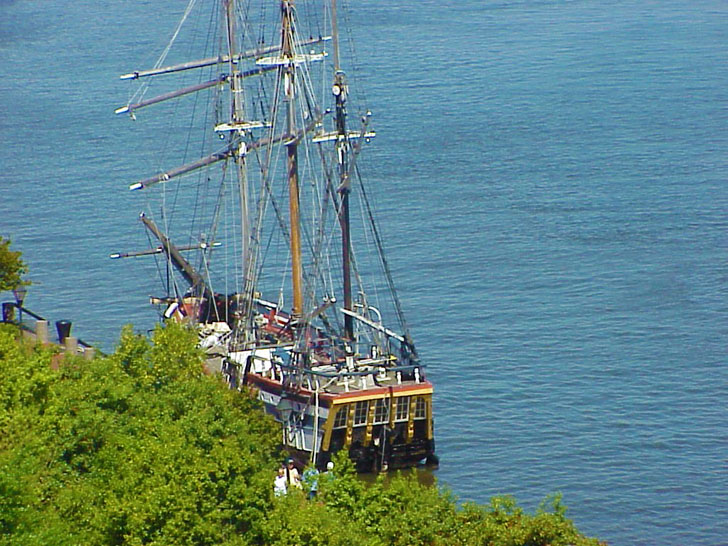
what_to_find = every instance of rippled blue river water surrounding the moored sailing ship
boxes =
[0,0,728,545]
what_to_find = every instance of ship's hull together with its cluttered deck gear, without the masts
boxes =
[201,300,439,472]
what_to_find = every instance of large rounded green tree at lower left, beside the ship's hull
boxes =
[0,324,280,544]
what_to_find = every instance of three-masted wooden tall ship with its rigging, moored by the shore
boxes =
[112,0,438,471]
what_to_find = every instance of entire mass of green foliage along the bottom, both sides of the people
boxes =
[0,325,597,545]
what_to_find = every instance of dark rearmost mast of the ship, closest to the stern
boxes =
[331,0,354,339]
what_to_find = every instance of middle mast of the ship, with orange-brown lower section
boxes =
[281,0,303,317]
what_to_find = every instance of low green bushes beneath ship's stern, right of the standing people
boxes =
[320,458,600,546]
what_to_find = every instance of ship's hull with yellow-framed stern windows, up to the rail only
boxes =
[241,352,437,472]
